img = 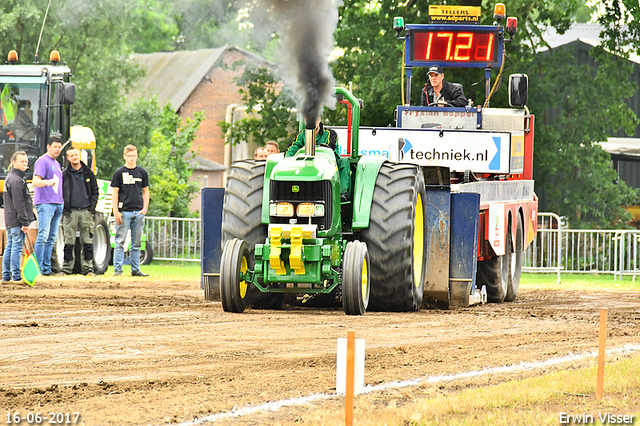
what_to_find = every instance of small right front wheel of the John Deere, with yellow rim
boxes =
[342,241,371,315]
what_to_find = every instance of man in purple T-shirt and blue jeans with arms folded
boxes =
[33,134,64,275]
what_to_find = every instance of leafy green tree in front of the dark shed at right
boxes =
[527,46,638,228]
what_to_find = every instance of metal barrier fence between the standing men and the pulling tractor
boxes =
[144,216,202,262]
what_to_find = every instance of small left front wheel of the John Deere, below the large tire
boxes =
[220,238,253,313]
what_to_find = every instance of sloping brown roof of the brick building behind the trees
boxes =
[130,45,264,110]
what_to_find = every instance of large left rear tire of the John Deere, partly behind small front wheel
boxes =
[222,160,276,309]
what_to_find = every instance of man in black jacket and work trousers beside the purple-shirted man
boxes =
[62,148,98,276]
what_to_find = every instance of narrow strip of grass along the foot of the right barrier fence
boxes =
[520,273,640,291]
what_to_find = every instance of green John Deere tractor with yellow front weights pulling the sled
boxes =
[220,88,426,315]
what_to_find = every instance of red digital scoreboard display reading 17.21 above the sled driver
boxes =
[407,25,503,67]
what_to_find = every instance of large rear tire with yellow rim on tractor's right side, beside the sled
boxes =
[361,163,427,311]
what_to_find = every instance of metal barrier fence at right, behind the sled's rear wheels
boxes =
[522,213,640,282]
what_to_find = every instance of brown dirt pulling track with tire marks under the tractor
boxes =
[0,277,640,425]
